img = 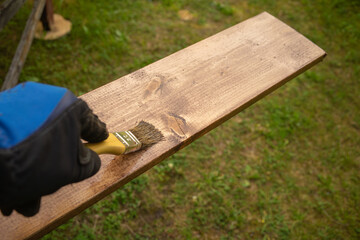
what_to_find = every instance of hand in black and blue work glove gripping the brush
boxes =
[0,82,108,217]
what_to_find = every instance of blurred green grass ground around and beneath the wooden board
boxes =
[0,0,360,239]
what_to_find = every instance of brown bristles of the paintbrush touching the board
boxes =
[130,121,164,148]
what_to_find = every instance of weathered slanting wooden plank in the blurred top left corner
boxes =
[1,0,46,91]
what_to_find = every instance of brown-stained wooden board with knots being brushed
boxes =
[0,13,326,239]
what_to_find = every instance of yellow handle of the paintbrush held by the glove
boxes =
[85,133,125,155]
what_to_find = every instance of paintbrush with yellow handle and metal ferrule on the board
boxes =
[85,121,164,155]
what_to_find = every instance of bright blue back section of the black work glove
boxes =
[0,82,77,149]
